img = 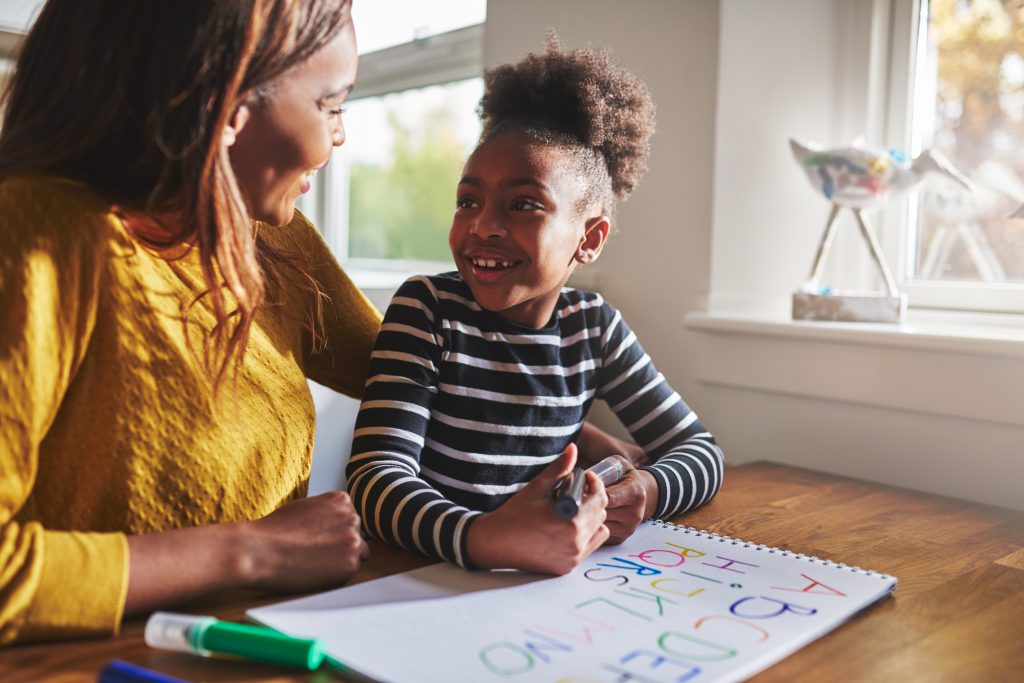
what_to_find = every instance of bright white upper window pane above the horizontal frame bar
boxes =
[352,0,487,54]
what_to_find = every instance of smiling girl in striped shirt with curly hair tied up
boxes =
[347,36,722,573]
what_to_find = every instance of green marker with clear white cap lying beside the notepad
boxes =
[145,612,325,671]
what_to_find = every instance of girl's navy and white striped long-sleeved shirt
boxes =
[346,272,723,566]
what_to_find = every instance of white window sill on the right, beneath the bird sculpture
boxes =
[685,312,1024,426]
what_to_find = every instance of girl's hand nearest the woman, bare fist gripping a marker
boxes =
[466,443,608,574]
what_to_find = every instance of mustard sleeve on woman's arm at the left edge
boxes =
[0,180,128,643]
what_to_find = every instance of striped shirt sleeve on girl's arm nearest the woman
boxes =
[346,276,480,566]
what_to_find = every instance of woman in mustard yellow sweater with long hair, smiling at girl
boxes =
[0,0,379,642]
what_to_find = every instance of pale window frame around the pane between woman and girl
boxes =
[299,24,484,280]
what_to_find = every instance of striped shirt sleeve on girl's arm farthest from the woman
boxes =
[599,303,723,519]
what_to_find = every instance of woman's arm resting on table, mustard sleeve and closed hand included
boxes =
[0,198,369,643]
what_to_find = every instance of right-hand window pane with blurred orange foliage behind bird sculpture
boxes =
[914,0,1024,283]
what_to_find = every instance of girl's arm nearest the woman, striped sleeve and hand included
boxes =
[346,278,607,573]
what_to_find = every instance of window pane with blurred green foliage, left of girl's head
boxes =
[341,78,483,261]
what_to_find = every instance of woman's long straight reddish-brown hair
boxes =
[0,0,351,387]
